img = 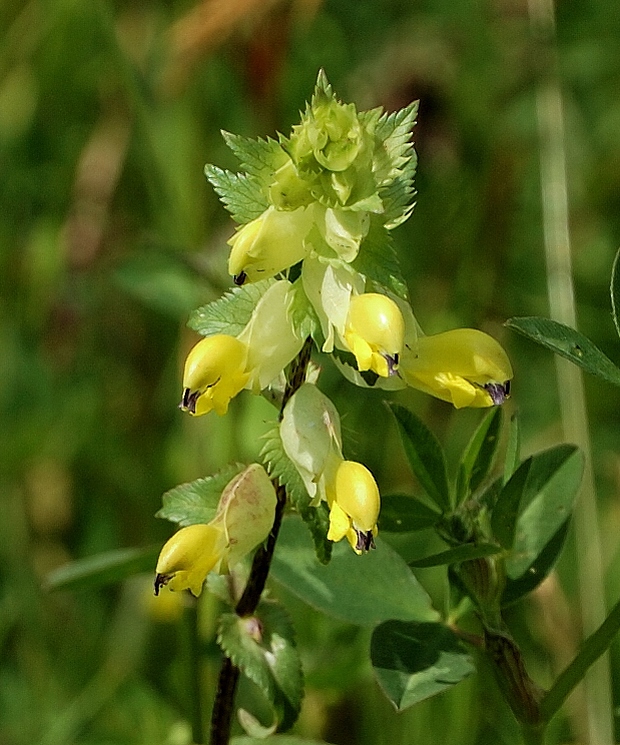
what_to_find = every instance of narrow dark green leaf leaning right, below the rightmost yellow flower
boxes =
[456,406,502,503]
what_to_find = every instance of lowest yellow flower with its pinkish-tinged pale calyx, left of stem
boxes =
[155,463,276,596]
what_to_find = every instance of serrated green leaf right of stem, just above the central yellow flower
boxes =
[351,216,408,300]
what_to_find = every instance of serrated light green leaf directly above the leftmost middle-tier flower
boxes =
[187,279,276,336]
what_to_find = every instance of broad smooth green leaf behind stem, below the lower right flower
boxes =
[272,517,438,626]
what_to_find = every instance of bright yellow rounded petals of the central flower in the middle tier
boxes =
[344,292,405,378]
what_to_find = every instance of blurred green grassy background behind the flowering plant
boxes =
[0,0,620,745]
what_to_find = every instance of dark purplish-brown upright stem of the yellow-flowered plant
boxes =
[210,338,312,745]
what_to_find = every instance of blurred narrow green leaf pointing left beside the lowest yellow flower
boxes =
[44,545,161,590]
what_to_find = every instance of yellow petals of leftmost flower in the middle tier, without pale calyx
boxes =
[180,334,249,416]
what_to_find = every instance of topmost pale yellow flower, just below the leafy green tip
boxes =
[228,207,314,285]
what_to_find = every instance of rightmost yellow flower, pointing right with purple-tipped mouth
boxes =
[399,329,513,409]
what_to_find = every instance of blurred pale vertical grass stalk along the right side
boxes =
[528,0,614,745]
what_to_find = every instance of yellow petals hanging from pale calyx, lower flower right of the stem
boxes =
[327,460,381,554]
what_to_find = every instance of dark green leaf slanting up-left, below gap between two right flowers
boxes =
[388,403,451,512]
